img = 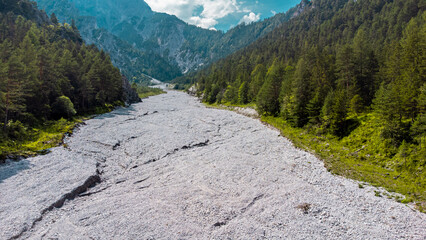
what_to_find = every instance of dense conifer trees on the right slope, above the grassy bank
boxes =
[191,0,426,165]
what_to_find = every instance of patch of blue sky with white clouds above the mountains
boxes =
[145,0,300,31]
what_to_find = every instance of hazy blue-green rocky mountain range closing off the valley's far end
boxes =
[36,0,304,81]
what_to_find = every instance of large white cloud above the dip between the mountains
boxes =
[145,0,241,29]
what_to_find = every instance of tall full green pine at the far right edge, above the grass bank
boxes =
[374,15,426,146]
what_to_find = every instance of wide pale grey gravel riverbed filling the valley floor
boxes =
[0,92,426,239]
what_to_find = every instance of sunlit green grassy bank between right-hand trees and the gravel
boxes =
[262,114,426,211]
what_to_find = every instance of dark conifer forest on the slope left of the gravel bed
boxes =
[0,0,125,159]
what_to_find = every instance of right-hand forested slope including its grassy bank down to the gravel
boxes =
[188,0,426,206]
